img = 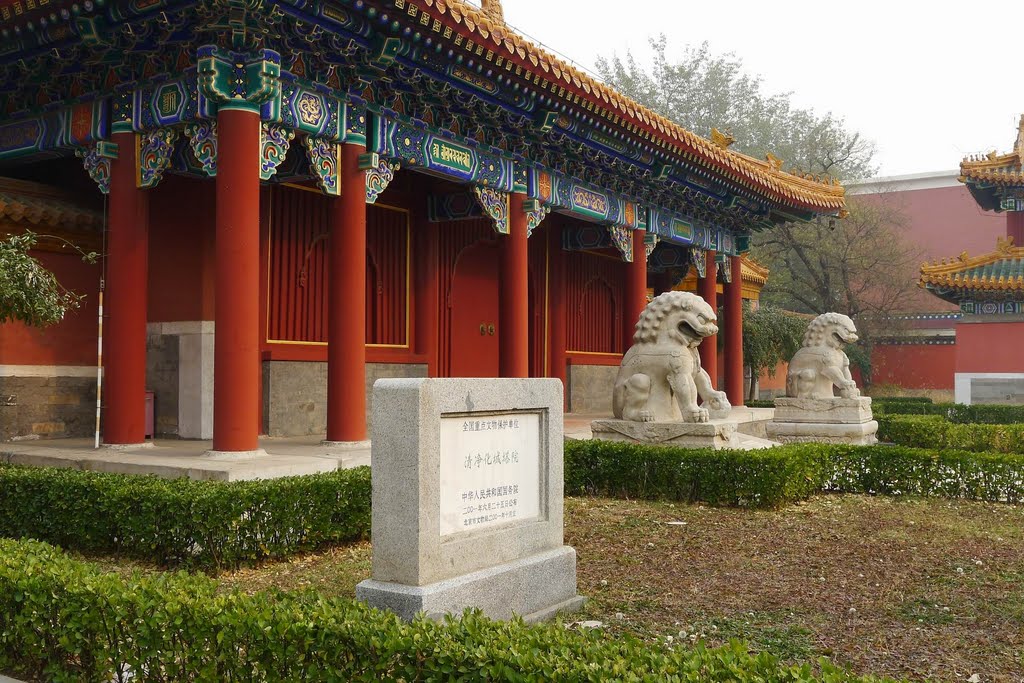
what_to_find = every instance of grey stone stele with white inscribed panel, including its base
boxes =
[356,379,583,622]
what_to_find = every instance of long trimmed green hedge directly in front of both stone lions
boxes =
[565,440,1024,507]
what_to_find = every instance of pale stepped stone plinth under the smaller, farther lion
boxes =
[766,396,879,445]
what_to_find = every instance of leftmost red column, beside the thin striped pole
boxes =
[103,129,150,444]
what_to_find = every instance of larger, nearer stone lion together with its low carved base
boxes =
[591,292,738,449]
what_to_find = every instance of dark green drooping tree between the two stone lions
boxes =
[743,302,808,400]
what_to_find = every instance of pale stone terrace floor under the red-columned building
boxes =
[0,408,773,483]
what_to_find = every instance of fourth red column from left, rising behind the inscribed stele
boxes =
[498,193,529,377]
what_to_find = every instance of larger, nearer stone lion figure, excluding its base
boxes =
[611,292,732,422]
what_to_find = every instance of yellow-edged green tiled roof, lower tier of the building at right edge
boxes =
[919,237,1024,291]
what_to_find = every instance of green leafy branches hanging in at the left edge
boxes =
[0,232,96,327]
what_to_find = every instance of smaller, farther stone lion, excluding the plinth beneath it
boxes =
[785,313,860,398]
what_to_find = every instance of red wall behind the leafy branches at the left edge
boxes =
[0,252,99,366]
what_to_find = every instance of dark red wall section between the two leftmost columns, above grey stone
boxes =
[146,174,216,323]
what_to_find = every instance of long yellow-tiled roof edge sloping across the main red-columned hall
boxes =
[411,0,846,213]
